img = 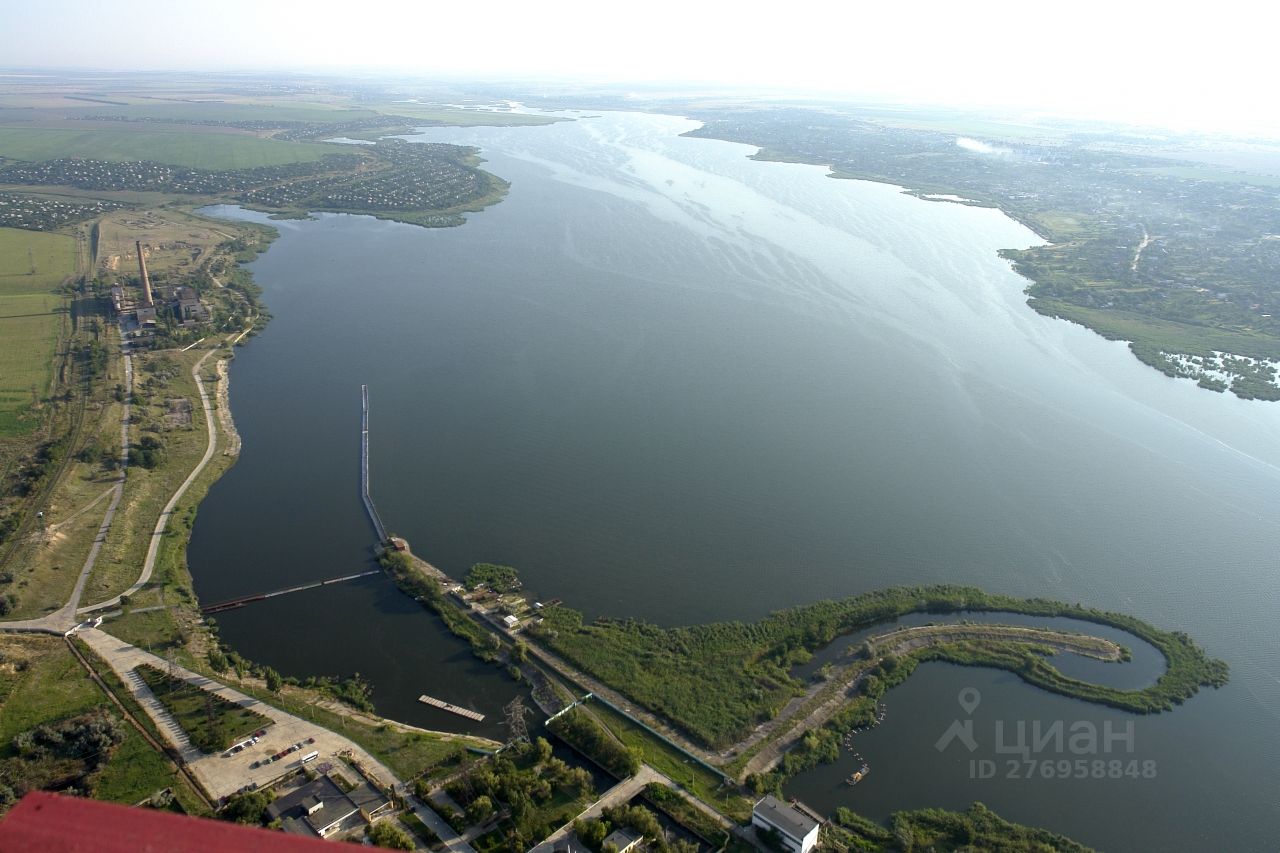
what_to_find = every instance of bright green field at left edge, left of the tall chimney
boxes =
[0,228,76,438]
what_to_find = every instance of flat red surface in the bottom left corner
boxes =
[0,790,334,853]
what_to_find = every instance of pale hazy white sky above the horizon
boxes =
[0,0,1280,129]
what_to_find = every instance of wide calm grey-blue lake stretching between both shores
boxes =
[189,114,1280,850]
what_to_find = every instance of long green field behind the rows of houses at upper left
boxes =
[0,124,334,170]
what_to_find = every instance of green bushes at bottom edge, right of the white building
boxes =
[824,803,1089,853]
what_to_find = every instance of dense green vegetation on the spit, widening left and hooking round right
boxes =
[531,585,1228,748]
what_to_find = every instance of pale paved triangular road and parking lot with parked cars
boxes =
[79,628,399,799]
